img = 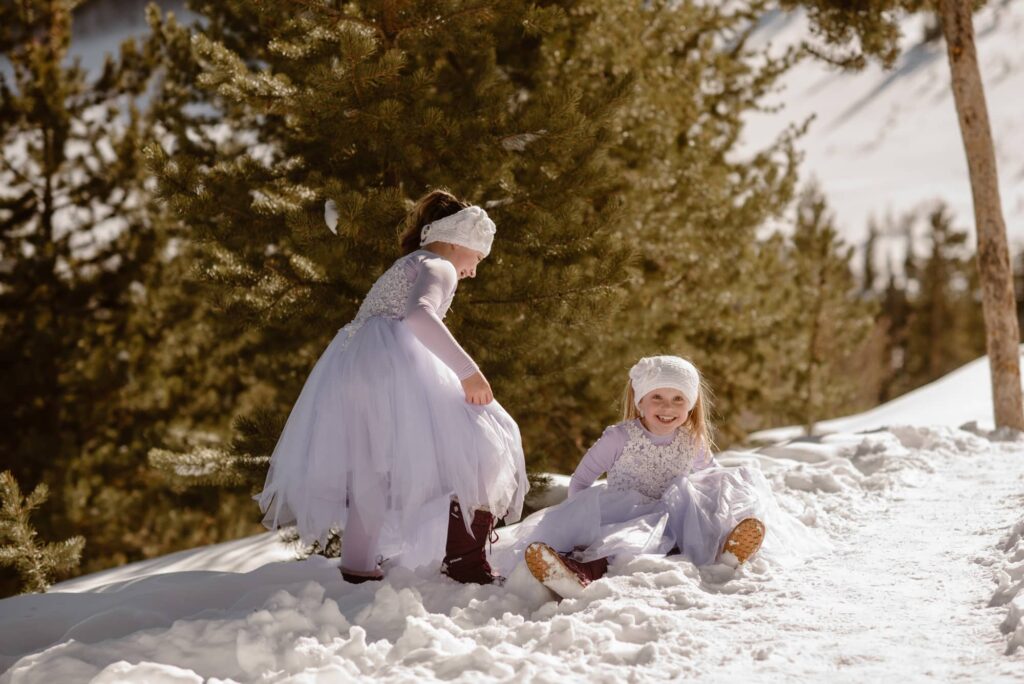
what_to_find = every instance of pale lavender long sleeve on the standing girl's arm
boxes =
[404,258,479,380]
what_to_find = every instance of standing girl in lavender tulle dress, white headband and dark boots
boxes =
[255,190,528,584]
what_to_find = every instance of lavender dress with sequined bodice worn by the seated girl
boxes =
[493,420,827,573]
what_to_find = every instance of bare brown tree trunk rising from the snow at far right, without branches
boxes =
[938,0,1024,430]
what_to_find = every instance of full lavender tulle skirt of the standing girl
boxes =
[254,315,528,567]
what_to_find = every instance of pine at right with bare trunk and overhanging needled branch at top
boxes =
[781,0,1024,430]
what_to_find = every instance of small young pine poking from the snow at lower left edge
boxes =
[0,470,85,592]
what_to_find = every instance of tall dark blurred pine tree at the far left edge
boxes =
[0,1,151,491]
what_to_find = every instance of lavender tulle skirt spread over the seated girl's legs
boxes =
[493,466,828,573]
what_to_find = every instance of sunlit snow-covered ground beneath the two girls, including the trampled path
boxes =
[0,360,1024,683]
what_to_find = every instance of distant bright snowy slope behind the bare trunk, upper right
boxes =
[744,0,1024,252]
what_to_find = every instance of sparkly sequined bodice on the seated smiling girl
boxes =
[608,421,697,500]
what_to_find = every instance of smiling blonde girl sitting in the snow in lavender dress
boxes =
[495,356,823,597]
